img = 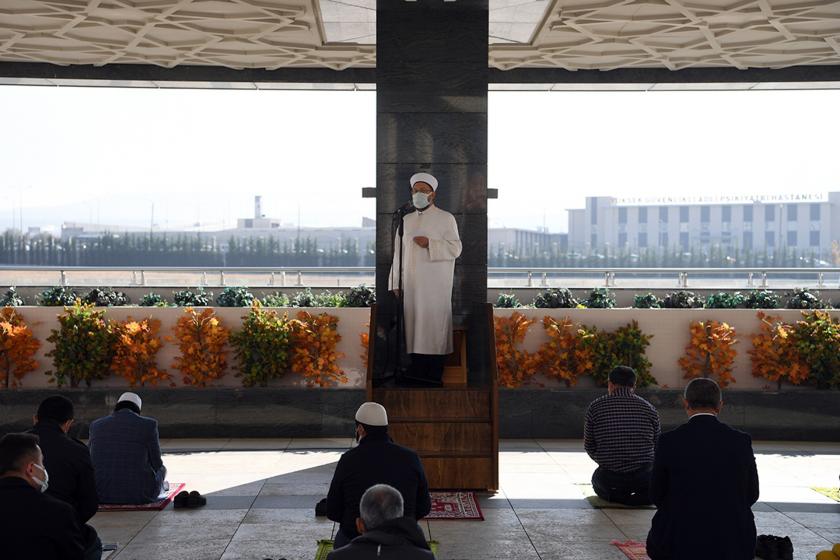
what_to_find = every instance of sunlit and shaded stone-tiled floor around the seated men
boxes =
[92,438,840,560]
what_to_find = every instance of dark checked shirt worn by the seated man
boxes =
[583,387,661,473]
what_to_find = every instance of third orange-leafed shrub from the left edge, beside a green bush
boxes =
[170,307,230,387]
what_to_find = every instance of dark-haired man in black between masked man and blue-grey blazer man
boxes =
[30,395,102,560]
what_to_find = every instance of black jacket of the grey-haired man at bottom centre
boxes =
[327,517,435,560]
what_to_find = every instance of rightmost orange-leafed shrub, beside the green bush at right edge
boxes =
[749,311,811,387]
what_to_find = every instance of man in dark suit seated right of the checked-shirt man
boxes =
[647,379,758,560]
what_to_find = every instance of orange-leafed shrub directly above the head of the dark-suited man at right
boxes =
[679,321,738,387]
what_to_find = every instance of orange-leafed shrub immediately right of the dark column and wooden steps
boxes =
[493,311,537,388]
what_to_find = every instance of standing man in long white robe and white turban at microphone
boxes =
[388,173,461,386]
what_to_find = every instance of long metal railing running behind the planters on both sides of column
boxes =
[0,265,840,289]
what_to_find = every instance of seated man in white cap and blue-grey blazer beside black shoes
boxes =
[90,393,166,504]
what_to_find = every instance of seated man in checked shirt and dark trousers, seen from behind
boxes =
[583,366,660,506]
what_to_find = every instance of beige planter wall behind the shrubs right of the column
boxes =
[494,308,840,391]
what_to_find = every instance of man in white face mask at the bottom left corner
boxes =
[0,434,84,560]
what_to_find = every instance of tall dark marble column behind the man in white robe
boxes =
[376,0,489,384]
